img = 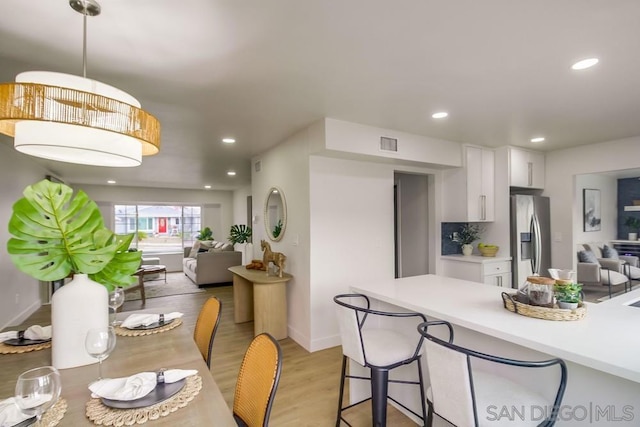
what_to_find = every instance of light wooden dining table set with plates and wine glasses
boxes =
[0,309,237,427]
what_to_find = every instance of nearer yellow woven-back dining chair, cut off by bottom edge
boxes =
[233,333,282,427]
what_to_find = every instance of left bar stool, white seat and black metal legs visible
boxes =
[333,294,426,427]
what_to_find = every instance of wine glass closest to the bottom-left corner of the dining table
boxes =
[15,366,62,421]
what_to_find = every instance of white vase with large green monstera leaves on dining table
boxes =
[7,180,142,368]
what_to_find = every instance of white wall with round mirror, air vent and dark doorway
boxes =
[252,119,461,351]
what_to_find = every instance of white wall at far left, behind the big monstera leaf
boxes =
[0,142,60,329]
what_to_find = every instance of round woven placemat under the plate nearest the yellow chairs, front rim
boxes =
[87,375,202,427]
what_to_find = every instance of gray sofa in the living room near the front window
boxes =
[182,247,242,286]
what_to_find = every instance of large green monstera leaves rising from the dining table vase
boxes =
[7,180,141,288]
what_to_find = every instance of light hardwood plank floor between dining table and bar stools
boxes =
[20,273,416,427]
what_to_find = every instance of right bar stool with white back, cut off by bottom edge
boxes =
[418,320,567,427]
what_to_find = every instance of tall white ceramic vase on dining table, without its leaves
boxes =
[51,274,109,369]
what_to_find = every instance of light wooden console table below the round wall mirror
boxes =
[229,265,293,340]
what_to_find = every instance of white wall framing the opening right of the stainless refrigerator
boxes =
[544,137,640,268]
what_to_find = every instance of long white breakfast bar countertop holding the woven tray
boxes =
[351,274,640,383]
